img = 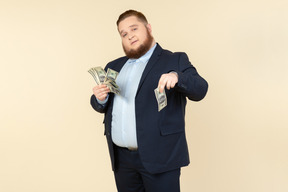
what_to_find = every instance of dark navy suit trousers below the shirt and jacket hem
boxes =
[114,146,181,192]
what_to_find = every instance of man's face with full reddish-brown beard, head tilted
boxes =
[118,16,154,59]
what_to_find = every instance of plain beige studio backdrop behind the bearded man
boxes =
[0,0,288,192]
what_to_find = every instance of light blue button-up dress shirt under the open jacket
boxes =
[112,44,156,148]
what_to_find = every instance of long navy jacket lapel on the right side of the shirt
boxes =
[136,44,163,96]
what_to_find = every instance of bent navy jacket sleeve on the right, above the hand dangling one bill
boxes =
[175,53,208,101]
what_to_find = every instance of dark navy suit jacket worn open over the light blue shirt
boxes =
[91,44,208,173]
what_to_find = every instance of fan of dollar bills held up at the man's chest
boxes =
[88,67,120,95]
